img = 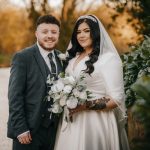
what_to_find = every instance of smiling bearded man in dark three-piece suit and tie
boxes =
[7,15,63,150]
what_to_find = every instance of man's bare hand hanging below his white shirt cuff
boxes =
[18,132,32,144]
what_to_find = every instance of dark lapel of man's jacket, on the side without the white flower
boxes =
[34,44,47,83]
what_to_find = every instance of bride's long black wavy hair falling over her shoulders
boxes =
[68,16,100,74]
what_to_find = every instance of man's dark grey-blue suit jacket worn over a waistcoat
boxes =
[7,44,62,138]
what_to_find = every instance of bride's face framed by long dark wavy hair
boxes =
[77,22,92,50]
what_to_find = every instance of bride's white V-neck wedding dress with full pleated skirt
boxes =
[55,53,129,150]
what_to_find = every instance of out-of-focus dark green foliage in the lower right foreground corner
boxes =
[131,75,150,150]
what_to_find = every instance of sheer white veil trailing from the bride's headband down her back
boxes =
[67,15,129,150]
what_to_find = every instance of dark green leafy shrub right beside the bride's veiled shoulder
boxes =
[122,36,150,107]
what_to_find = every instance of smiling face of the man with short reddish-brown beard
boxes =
[35,23,59,51]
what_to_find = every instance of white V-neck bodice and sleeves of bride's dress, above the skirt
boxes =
[66,53,124,100]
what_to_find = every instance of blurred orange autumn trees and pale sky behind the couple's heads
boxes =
[0,0,144,67]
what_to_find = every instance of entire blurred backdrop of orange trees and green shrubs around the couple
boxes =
[0,0,150,150]
